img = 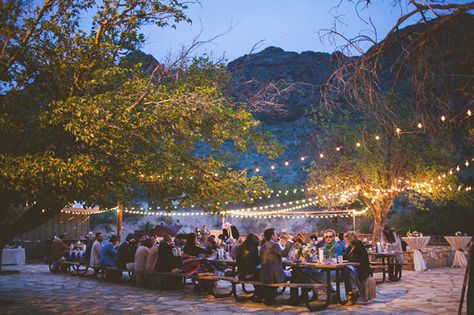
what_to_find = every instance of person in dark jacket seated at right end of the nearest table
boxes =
[342,233,370,305]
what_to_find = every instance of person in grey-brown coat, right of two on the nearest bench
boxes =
[260,229,290,305]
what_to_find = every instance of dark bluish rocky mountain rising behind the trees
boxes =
[130,14,474,188]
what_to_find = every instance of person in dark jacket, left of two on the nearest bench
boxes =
[235,233,262,302]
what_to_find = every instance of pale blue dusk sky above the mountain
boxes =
[143,0,414,61]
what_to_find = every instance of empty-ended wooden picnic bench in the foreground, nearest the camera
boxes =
[232,278,331,312]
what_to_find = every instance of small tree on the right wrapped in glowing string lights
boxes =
[308,95,470,240]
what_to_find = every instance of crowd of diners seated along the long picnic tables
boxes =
[51,223,406,305]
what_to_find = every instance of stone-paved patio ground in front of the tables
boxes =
[0,265,464,315]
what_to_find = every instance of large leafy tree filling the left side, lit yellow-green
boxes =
[0,0,278,244]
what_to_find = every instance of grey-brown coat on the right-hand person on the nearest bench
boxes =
[260,241,290,283]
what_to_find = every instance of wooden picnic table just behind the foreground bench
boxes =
[207,259,360,304]
